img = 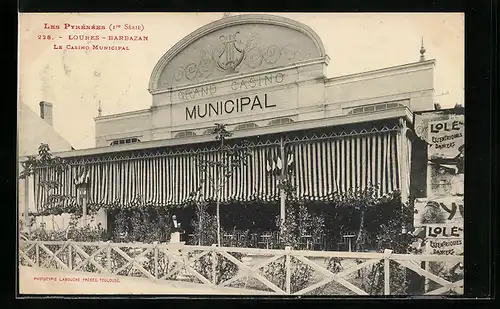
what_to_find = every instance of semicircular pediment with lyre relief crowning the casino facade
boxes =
[150,14,325,91]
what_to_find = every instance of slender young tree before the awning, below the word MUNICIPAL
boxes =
[194,123,250,246]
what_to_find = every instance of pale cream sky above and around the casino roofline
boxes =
[18,13,465,149]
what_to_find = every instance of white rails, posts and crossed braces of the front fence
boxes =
[19,240,464,295]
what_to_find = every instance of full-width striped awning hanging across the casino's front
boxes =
[34,124,411,211]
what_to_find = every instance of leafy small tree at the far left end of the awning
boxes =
[19,143,71,232]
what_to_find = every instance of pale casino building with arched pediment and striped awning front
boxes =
[26,14,435,233]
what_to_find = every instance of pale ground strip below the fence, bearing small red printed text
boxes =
[19,266,274,295]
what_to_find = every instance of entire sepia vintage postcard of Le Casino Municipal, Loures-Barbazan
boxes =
[18,12,466,296]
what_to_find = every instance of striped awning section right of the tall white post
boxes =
[291,132,399,200]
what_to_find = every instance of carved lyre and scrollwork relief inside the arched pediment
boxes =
[173,31,311,82]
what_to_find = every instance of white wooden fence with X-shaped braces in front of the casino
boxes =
[19,240,463,295]
